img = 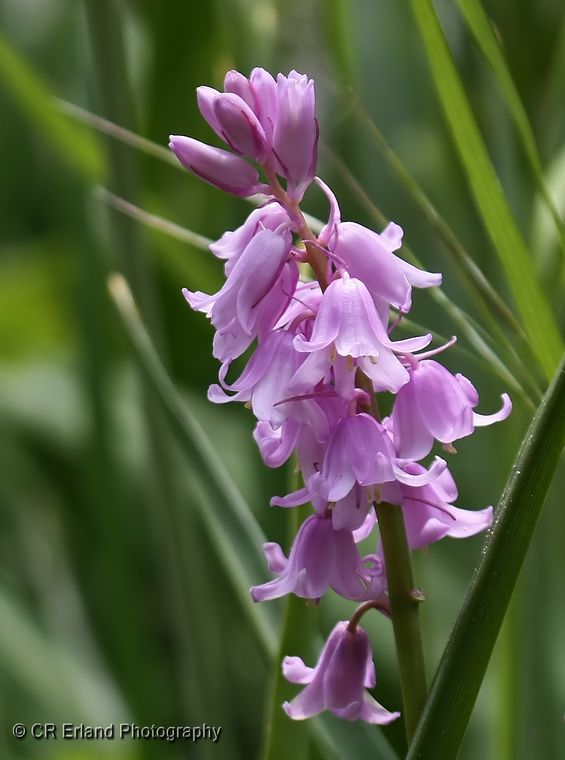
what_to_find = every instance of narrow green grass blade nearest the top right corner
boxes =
[458,0,565,254]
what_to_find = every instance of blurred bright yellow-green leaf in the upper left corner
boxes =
[0,35,105,181]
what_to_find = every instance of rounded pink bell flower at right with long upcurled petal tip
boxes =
[391,359,512,460]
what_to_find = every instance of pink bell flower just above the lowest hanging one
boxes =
[251,515,386,602]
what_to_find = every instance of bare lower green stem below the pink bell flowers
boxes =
[376,502,427,741]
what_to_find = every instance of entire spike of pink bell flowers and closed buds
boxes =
[170,69,511,724]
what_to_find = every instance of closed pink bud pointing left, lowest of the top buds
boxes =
[169,135,268,198]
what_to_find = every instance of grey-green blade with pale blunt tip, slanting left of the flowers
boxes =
[109,275,395,760]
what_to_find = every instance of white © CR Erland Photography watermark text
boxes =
[12,723,222,744]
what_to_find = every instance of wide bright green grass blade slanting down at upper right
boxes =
[412,0,563,379]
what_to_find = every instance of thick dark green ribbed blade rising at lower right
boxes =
[408,358,565,760]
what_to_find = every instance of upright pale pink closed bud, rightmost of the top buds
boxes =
[273,71,318,198]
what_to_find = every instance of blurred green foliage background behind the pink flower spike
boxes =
[0,0,565,760]
